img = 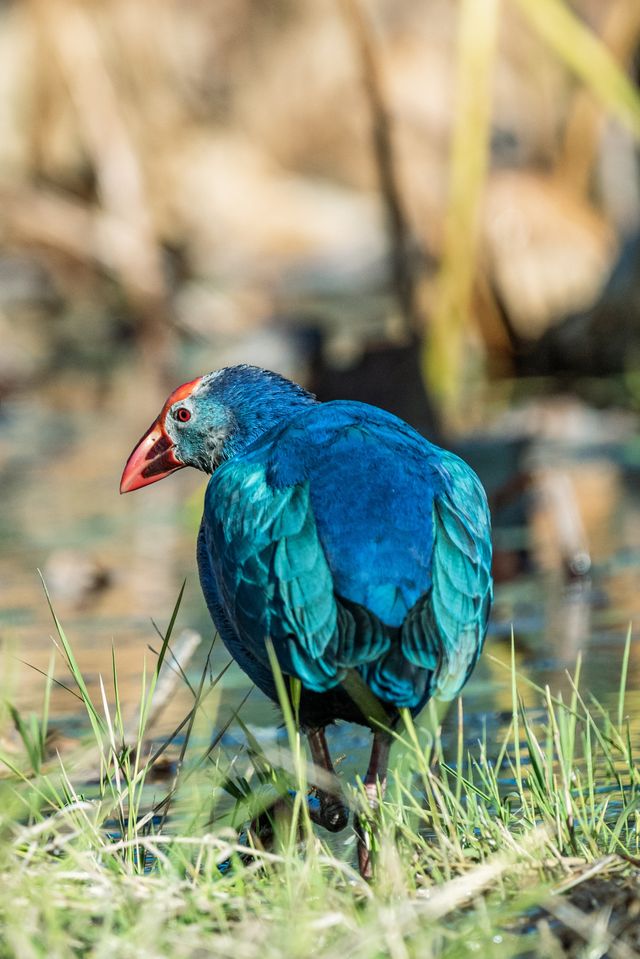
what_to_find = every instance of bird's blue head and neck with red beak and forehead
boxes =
[120,366,315,493]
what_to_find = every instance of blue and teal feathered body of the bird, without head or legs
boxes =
[199,402,491,718]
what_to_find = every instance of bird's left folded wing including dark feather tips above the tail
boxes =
[199,461,397,698]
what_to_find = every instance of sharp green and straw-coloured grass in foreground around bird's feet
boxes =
[0,606,640,959]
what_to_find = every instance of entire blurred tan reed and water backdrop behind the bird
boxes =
[0,0,640,760]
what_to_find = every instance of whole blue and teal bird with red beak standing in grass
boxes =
[120,365,493,878]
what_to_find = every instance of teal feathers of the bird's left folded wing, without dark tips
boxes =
[202,457,340,691]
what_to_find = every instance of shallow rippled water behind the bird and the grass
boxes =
[0,384,640,788]
